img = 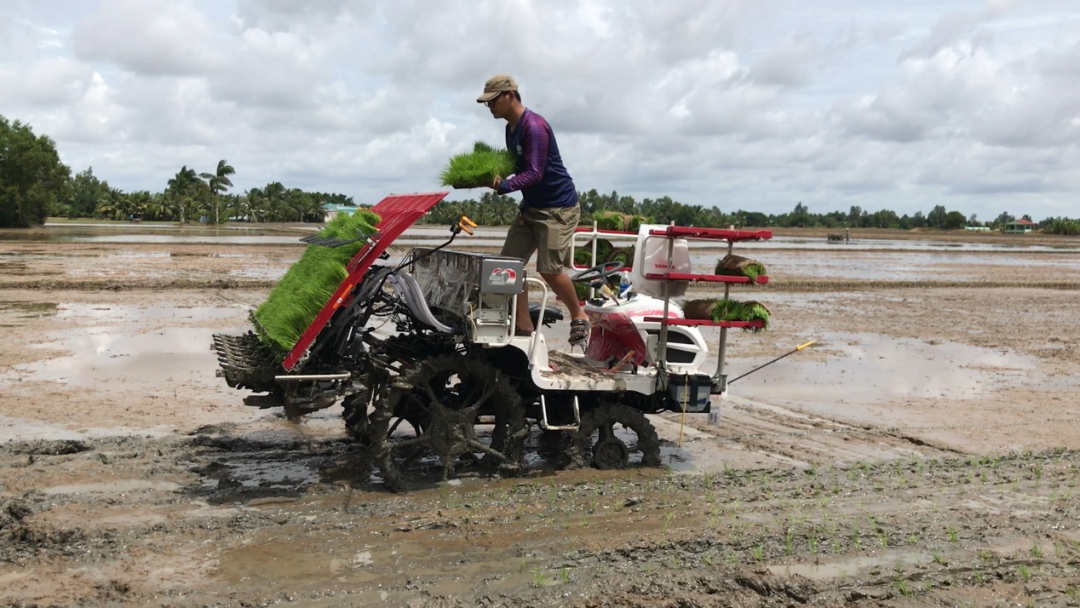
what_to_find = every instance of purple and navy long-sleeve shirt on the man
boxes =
[499,108,578,208]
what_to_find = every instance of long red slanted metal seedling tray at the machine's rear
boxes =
[282,192,449,371]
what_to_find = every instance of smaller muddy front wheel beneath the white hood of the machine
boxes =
[566,404,660,469]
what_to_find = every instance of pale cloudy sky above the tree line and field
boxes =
[0,0,1080,220]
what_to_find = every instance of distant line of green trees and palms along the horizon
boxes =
[0,116,1080,235]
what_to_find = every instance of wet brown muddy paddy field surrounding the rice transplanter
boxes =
[0,228,1080,607]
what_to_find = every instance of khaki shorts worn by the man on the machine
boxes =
[502,205,581,274]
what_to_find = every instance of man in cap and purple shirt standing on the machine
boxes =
[476,75,589,344]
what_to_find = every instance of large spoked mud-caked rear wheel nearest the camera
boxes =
[367,354,527,491]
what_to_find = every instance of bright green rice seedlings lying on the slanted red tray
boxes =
[255,210,379,355]
